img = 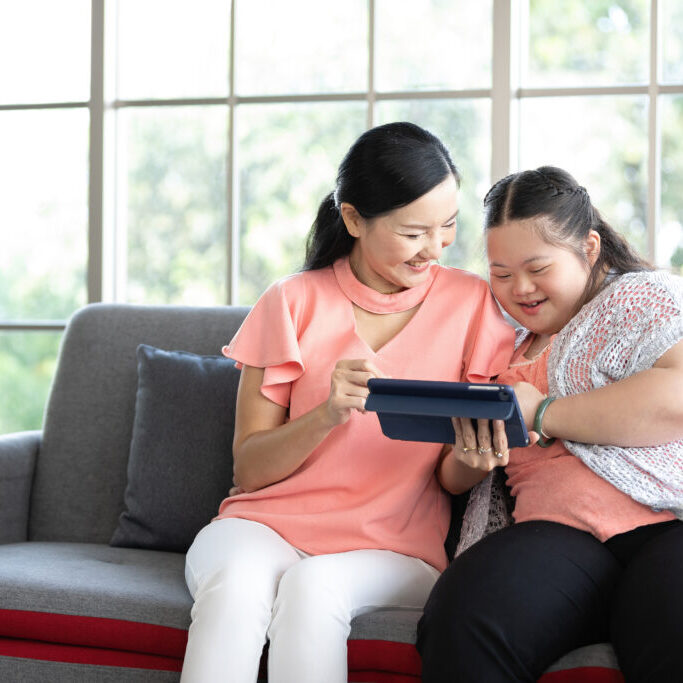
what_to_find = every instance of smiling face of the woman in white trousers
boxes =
[341,174,458,294]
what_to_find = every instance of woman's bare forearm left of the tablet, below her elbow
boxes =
[233,404,334,492]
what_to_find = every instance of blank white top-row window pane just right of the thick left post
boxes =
[116,0,230,99]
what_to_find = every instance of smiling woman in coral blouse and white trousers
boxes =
[182,123,514,683]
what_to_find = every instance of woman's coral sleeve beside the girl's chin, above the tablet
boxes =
[462,282,515,382]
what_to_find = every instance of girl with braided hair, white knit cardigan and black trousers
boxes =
[419,167,683,683]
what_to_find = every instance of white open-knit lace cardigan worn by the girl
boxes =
[456,271,683,554]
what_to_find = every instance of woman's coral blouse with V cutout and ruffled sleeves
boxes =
[217,258,514,570]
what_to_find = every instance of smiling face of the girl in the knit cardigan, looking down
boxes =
[486,219,600,335]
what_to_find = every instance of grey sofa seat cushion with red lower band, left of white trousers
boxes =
[0,542,192,657]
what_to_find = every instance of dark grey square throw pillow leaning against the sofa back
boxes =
[111,344,240,552]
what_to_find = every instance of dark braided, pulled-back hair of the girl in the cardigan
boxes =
[484,166,653,305]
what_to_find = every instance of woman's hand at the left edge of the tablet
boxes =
[323,358,386,425]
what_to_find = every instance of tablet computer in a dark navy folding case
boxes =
[365,378,529,448]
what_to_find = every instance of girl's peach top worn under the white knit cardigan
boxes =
[498,335,675,542]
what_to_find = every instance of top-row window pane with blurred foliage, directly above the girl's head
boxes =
[522,0,650,87]
